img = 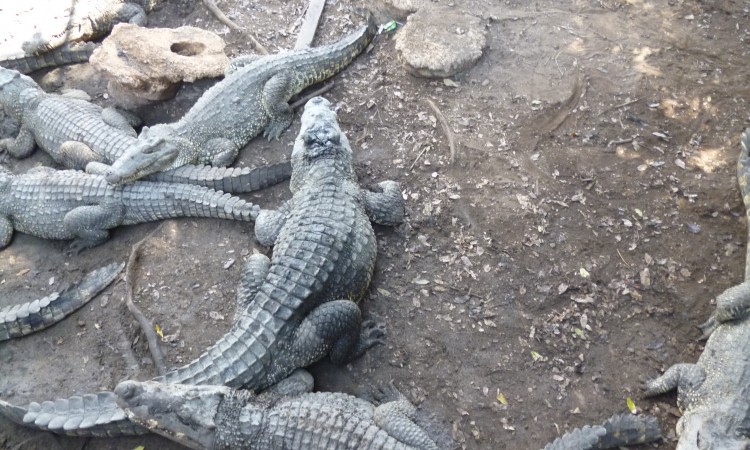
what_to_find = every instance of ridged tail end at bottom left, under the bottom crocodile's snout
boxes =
[0,391,149,437]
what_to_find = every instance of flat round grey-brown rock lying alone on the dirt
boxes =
[396,7,487,78]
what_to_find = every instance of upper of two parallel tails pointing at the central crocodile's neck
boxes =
[148,162,292,194]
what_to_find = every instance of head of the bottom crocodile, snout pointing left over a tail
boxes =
[115,381,232,448]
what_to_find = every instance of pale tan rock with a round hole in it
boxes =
[90,23,229,108]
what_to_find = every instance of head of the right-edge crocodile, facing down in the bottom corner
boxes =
[676,408,750,450]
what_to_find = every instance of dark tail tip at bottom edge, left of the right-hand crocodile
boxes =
[544,414,661,450]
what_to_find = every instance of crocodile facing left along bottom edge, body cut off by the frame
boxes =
[115,372,438,450]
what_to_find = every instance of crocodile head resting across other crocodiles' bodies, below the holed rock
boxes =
[103,133,180,184]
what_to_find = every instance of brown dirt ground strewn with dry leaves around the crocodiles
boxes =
[0,0,750,450]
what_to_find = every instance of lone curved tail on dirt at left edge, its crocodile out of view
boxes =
[0,263,125,341]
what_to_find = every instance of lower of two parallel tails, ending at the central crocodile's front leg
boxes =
[121,181,260,225]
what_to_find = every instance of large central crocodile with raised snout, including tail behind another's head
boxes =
[0,97,404,435]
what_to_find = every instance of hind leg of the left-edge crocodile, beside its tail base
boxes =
[63,205,125,253]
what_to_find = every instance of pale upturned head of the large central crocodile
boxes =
[291,97,354,191]
